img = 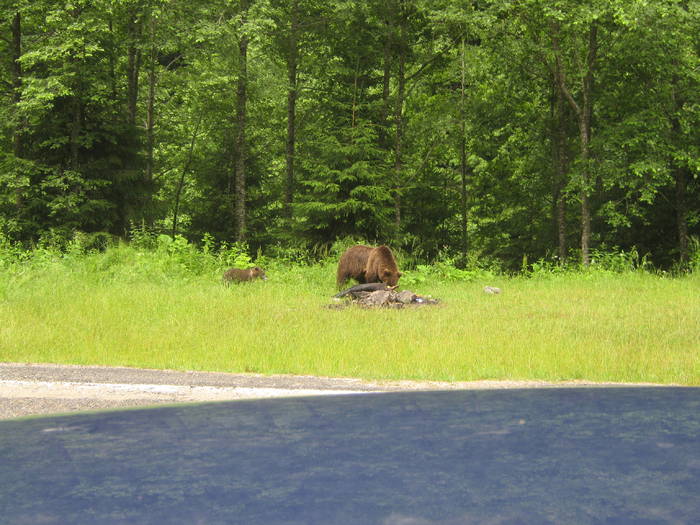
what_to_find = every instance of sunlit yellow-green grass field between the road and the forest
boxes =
[0,267,700,385]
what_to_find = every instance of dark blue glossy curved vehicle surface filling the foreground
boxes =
[0,382,700,525]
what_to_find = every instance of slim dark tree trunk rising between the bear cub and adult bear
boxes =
[284,0,299,219]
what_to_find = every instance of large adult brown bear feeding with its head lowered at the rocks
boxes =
[336,245,401,289]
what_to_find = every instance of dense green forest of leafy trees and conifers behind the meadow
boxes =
[0,0,700,268]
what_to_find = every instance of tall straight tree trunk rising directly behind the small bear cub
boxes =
[234,0,249,242]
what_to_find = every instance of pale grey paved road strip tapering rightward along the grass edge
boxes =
[0,363,668,419]
